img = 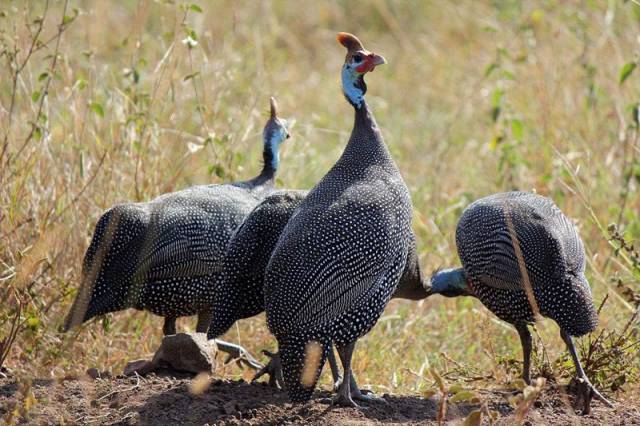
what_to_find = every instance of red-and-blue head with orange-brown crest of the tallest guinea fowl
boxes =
[337,33,387,108]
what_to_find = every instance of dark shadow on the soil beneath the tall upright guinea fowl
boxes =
[134,380,478,425]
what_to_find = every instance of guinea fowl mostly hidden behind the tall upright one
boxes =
[207,189,426,386]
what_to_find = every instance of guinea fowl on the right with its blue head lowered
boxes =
[429,192,610,413]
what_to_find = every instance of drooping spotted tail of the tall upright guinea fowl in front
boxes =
[278,335,331,402]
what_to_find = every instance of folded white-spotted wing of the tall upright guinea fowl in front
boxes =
[266,180,410,331]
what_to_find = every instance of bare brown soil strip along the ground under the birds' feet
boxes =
[0,371,640,426]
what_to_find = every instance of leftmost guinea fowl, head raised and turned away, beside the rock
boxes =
[64,98,289,366]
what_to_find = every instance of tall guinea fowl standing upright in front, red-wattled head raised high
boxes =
[264,33,412,406]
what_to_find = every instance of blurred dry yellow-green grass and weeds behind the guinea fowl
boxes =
[0,0,640,406]
